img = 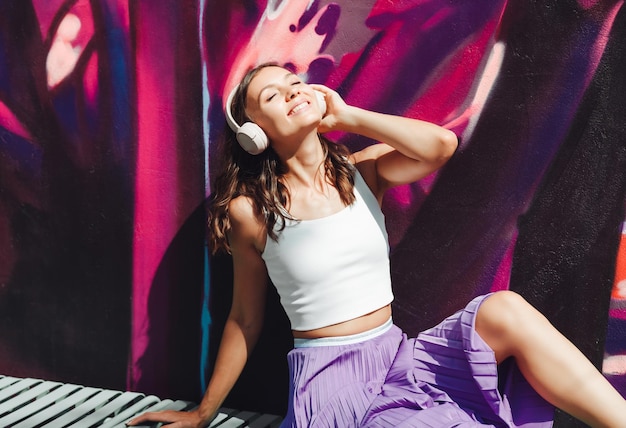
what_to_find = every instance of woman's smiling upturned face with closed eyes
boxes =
[246,66,322,144]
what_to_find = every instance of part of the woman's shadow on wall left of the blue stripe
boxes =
[134,204,206,402]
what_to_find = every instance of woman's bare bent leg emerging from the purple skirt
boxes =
[476,291,626,428]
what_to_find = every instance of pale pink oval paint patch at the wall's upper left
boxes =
[46,13,82,88]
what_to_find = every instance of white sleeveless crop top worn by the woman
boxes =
[262,169,393,331]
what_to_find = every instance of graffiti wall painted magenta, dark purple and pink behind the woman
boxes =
[0,0,626,423]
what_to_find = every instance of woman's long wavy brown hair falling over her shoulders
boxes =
[208,63,355,254]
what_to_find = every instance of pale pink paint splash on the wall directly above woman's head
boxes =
[223,0,333,102]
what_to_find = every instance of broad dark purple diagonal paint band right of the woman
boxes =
[393,0,610,329]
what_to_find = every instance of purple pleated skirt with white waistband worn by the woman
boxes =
[281,296,554,428]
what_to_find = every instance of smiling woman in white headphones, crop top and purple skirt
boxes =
[131,64,626,427]
